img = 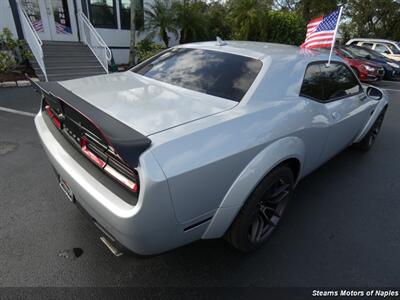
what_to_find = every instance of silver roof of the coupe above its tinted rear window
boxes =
[176,41,341,62]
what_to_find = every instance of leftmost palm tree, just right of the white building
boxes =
[144,0,178,48]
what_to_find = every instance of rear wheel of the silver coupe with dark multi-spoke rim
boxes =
[226,165,294,252]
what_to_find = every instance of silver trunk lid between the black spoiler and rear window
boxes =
[60,71,237,136]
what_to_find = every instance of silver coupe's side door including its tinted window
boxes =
[304,62,376,160]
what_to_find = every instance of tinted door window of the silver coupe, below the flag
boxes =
[321,63,361,101]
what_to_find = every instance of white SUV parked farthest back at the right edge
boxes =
[346,38,400,61]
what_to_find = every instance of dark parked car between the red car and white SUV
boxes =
[344,46,400,80]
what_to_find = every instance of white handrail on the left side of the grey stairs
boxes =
[18,2,48,81]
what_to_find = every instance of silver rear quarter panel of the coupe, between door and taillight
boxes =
[150,97,327,224]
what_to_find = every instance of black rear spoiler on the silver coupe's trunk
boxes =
[26,76,151,169]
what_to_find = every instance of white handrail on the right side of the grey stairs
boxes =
[78,11,112,74]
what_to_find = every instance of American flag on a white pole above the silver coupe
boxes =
[300,8,341,48]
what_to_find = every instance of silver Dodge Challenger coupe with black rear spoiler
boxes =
[35,41,388,255]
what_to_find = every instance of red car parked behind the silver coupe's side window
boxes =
[335,47,385,82]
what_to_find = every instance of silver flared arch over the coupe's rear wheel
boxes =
[202,136,305,239]
